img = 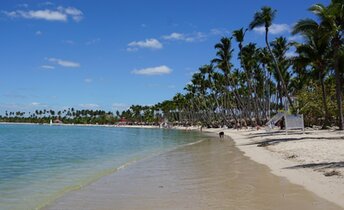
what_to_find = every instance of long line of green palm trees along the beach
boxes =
[0,0,344,130]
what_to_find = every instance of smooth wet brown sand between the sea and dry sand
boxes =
[47,138,342,210]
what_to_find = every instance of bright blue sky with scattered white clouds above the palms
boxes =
[0,0,329,114]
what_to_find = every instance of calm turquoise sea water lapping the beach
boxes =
[0,125,204,210]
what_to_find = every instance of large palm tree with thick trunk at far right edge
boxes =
[294,0,344,130]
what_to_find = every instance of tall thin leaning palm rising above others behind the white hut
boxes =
[249,7,294,108]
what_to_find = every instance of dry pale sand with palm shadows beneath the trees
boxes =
[200,128,344,208]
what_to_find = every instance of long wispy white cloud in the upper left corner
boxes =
[2,7,83,22]
